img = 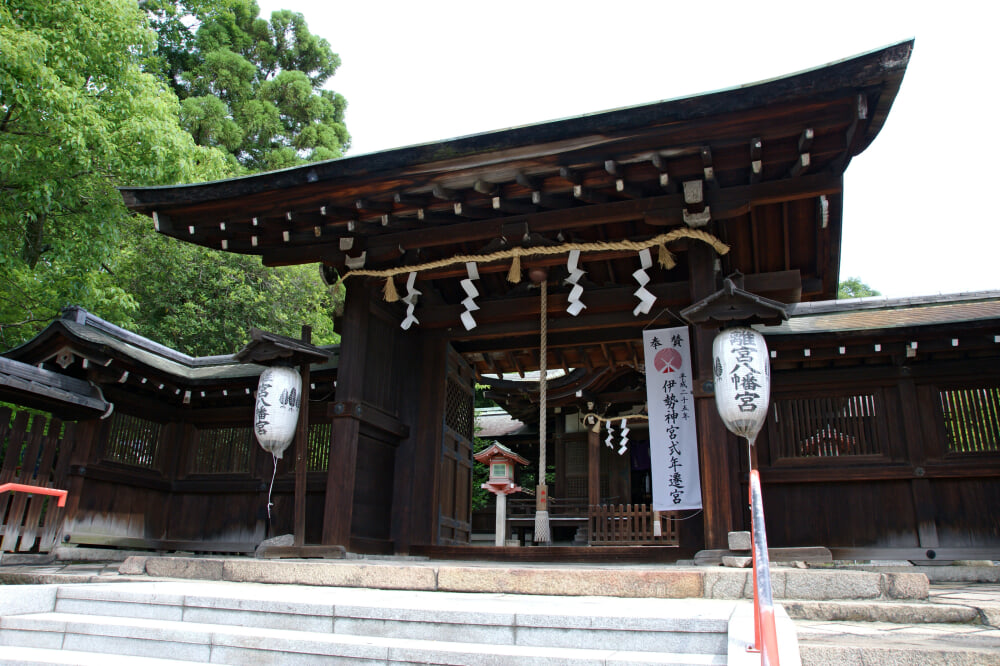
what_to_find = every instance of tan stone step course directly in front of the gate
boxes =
[115,557,928,600]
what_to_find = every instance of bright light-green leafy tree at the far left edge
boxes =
[0,0,230,346]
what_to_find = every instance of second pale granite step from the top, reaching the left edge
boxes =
[0,612,726,666]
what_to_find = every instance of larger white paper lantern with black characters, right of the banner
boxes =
[712,327,771,441]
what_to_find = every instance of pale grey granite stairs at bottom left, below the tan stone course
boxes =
[0,581,780,665]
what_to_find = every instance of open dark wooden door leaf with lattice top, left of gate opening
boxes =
[437,348,476,545]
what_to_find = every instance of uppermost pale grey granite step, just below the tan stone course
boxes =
[41,583,735,654]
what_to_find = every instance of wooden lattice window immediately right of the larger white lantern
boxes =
[771,393,883,458]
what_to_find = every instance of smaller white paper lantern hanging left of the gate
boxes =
[253,367,302,458]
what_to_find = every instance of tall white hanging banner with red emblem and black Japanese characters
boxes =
[642,326,701,511]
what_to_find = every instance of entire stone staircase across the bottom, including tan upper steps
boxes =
[0,557,1000,666]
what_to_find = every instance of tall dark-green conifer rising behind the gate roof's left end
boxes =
[140,0,350,171]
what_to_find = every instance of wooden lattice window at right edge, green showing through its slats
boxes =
[941,386,1000,453]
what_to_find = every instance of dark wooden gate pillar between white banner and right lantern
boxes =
[688,243,736,548]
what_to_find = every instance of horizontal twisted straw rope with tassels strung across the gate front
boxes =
[334,227,729,303]
